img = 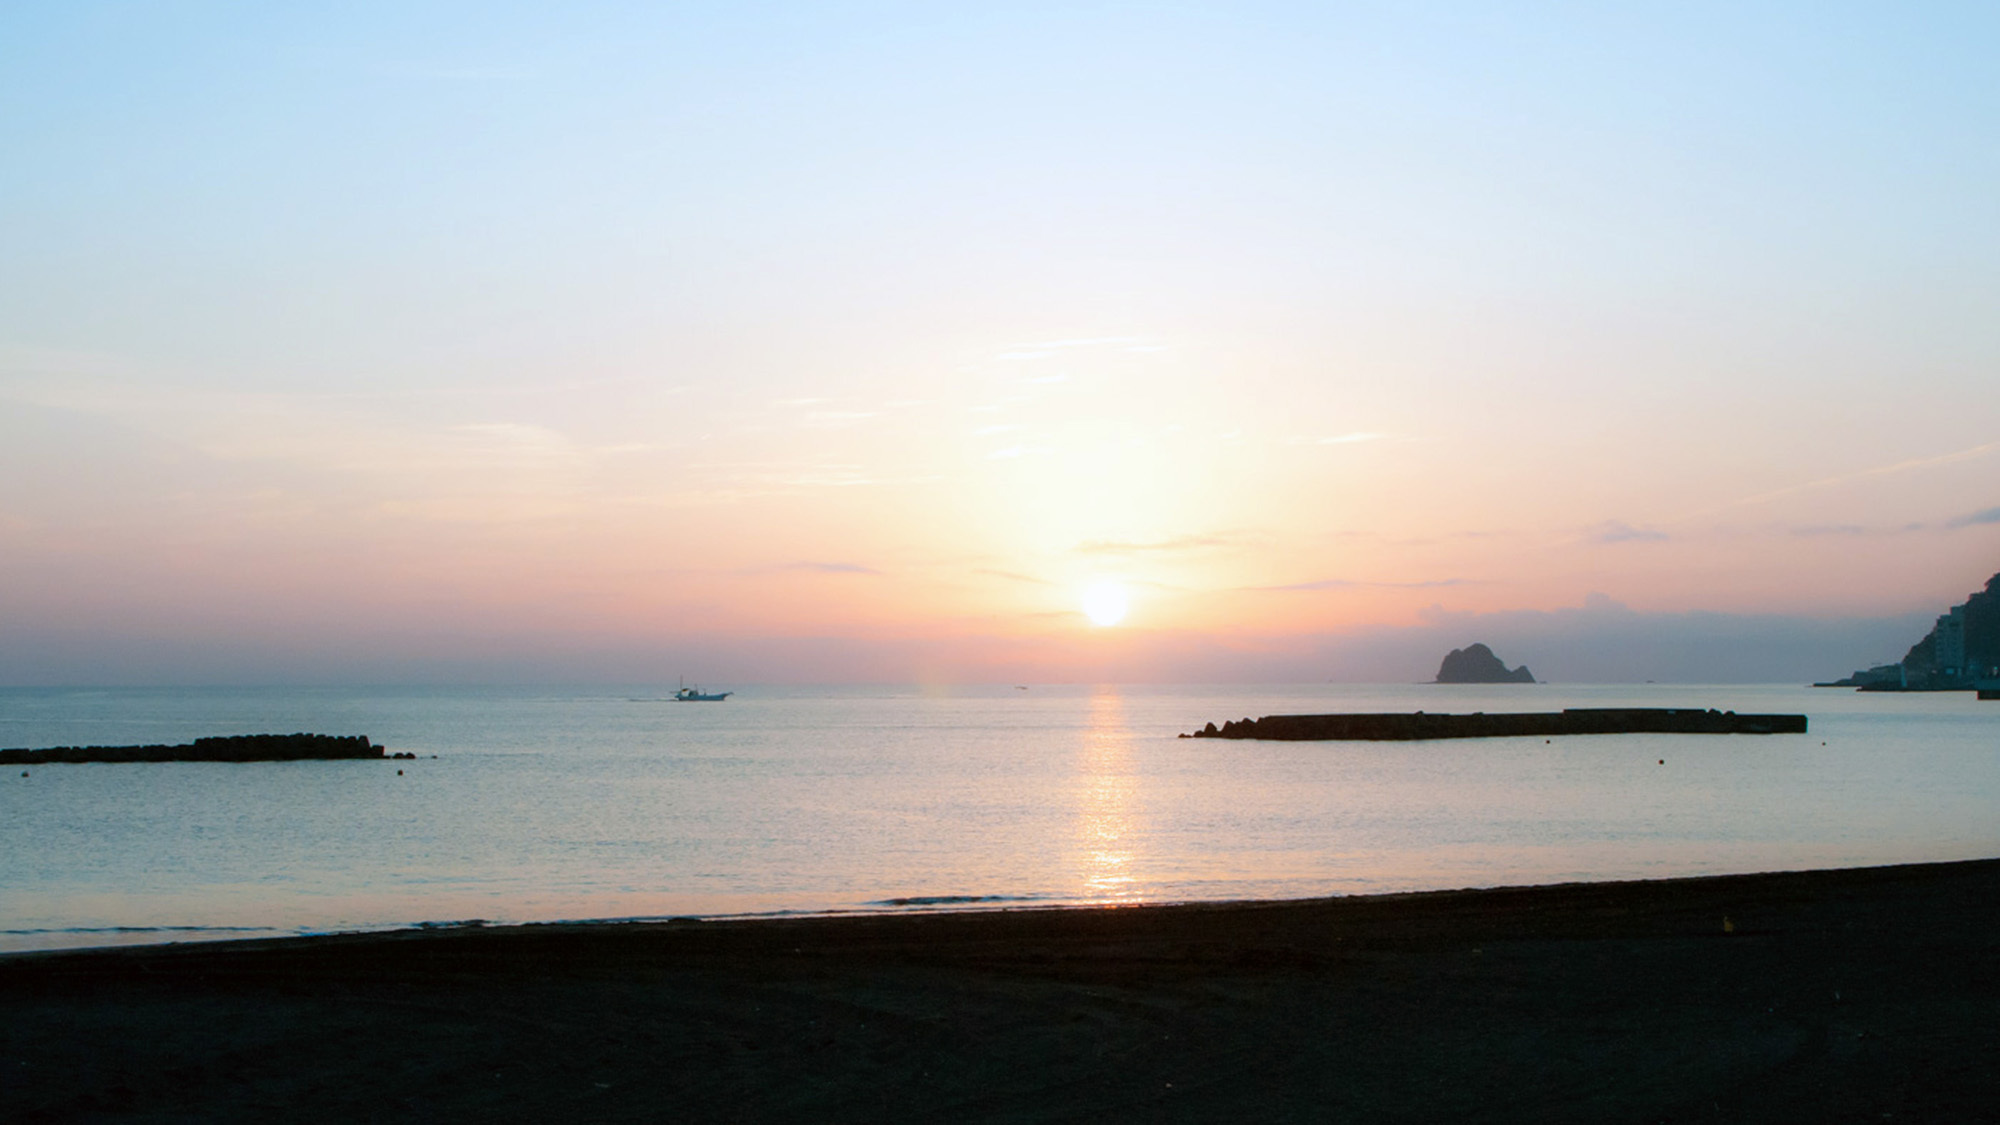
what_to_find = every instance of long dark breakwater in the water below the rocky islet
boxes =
[1182,707,1806,743]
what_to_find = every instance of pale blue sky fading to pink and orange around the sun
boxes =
[0,0,2000,685]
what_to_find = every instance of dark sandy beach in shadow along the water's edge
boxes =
[0,861,2000,1121]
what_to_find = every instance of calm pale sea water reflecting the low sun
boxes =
[0,685,2000,951]
